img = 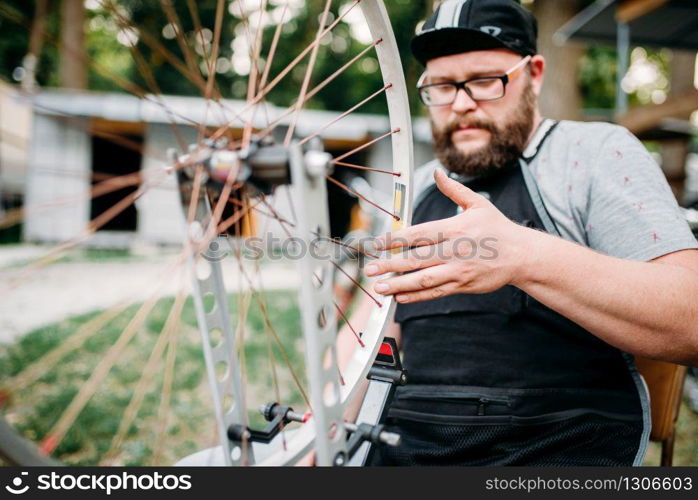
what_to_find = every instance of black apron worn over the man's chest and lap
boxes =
[372,163,643,466]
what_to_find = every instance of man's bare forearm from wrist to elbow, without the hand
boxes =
[514,232,698,363]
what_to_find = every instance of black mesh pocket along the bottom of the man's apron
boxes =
[373,409,642,466]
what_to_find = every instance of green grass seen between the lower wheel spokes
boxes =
[0,292,304,465]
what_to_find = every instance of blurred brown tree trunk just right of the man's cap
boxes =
[533,0,584,120]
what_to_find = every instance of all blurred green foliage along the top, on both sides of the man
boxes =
[0,0,671,113]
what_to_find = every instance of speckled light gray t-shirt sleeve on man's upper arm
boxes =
[585,127,698,261]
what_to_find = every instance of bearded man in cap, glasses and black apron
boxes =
[340,0,698,466]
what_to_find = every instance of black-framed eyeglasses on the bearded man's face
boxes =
[417,56,531,106]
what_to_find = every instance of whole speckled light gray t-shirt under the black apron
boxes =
[414,120,698,261]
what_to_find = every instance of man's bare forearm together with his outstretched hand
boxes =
[366,170,698,363]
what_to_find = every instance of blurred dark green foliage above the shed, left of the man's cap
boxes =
[0,0,426,112]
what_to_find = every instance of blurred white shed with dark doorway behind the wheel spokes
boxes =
[19,90,430,248]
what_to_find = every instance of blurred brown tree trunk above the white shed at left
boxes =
[59,0,87,89]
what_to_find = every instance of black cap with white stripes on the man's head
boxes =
[411,0,538,65]
